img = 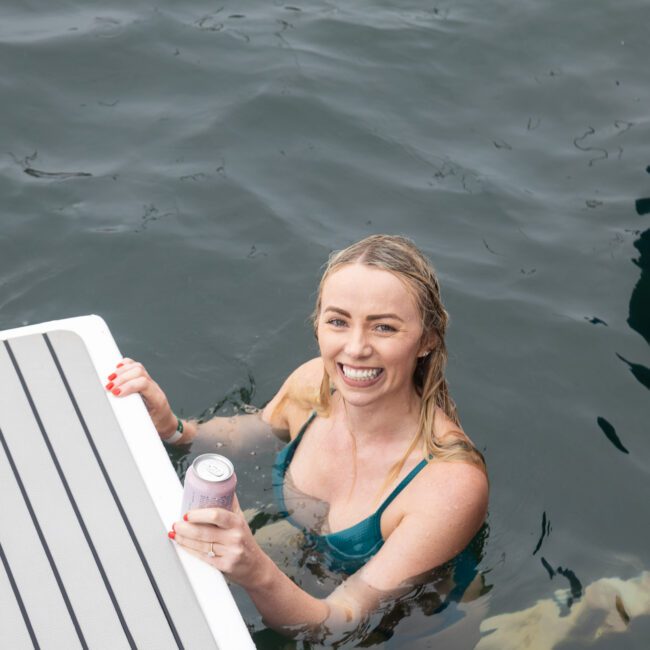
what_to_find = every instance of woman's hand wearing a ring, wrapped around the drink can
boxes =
[169,496,272,589]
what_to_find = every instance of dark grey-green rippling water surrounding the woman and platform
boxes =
[0,0,650,648]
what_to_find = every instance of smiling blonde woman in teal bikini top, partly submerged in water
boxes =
[107,235,488,638]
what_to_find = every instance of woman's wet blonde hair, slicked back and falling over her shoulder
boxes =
[312,235,485,484]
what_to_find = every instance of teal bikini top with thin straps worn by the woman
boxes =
[273,412,427,573]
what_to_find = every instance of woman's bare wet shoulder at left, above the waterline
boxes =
[262,357,323,437]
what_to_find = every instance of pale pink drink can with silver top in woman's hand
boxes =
[181,454,237,515]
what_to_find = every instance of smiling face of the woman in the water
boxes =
[318,264,427,406]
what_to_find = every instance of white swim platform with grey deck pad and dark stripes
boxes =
[0,316,254,650]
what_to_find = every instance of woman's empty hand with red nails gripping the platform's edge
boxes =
[106,359,178,439]
